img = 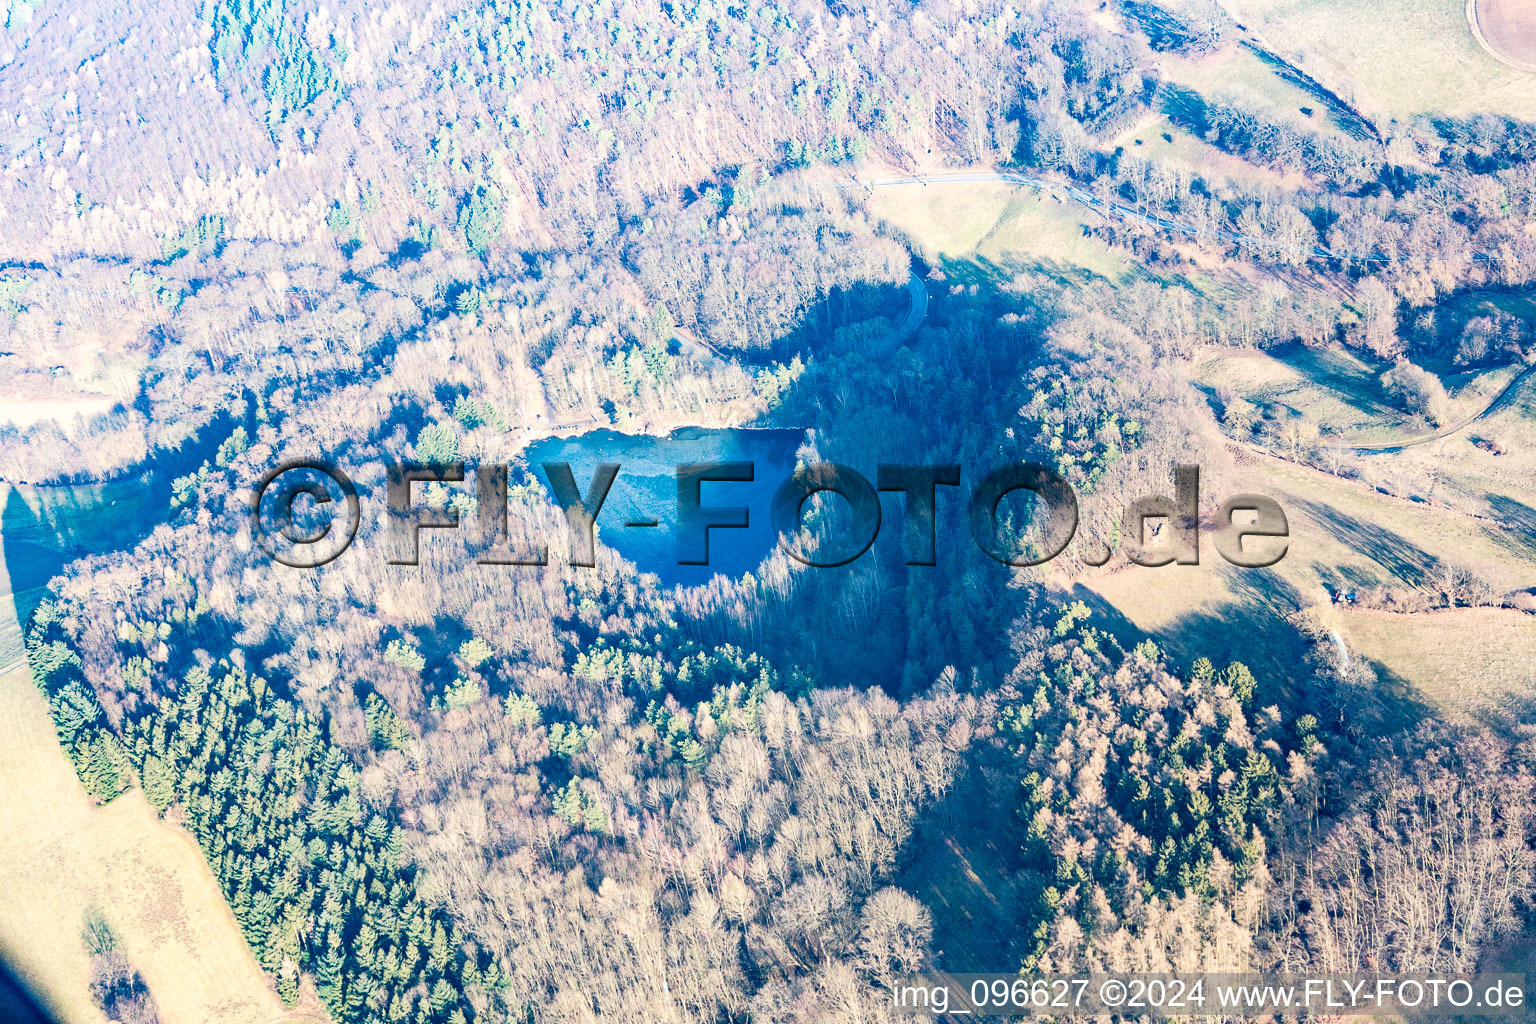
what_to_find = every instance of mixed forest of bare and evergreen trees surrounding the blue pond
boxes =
[0,0,1536,1024]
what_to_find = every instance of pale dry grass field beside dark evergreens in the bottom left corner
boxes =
[0,666,312,1024]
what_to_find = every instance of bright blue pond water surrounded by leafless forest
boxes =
[525,427,805,586]
